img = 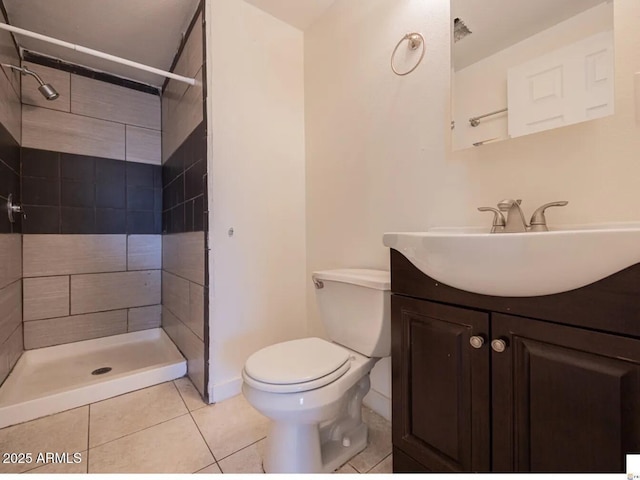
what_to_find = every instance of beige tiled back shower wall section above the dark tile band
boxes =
[22,62,161,165]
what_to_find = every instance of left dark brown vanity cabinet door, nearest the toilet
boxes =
[391,295,490,472]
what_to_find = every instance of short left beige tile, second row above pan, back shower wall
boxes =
[23,276,69,321]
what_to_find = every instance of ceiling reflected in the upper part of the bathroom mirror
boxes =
[451,0,613,70]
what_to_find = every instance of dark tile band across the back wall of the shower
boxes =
[21,148,162,234]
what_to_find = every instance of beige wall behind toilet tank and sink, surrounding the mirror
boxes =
[305,0,640,420]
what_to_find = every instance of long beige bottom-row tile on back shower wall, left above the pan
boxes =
[24,310,127,350]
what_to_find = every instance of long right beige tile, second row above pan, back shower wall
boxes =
[71,270,161,315]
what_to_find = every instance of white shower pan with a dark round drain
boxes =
[0,328,187,428]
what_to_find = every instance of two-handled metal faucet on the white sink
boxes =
[478,199,569,233]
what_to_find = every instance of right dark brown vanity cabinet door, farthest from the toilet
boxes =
[491,314,640,473]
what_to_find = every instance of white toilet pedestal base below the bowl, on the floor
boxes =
[263,375,370,473]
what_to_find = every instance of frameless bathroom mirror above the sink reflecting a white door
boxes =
[451,0,614,150]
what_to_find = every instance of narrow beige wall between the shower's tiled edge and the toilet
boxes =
[206,0,304,401]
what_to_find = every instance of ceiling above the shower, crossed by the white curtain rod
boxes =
[2,0,199,86]
